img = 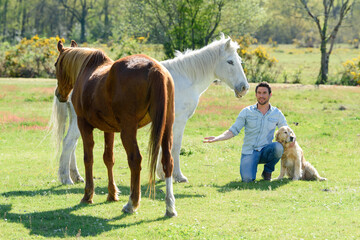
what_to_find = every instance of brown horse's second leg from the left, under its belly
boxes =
[103,133,119,201]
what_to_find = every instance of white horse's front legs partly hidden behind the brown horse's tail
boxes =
[156,119,188,182]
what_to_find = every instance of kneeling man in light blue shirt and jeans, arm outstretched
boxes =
[204,82,287,182]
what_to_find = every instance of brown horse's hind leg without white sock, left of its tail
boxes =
[121,123,142,213]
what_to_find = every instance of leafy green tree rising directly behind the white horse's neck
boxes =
[145,0,225,57]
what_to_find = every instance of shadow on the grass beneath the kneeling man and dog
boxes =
[215,178,291,192]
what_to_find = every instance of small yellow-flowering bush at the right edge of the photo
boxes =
[340,56,360,86]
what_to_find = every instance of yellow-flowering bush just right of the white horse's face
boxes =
[236,36,279,82]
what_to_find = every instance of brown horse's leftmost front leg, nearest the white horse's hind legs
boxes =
[78,118,94,203]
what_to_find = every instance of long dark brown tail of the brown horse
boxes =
[149,67,174,196]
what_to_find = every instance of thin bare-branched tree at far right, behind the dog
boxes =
[300,0,355,84]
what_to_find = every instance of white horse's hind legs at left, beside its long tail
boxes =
[59,103,84,184]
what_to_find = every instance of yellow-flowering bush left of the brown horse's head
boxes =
[0,35,65,77]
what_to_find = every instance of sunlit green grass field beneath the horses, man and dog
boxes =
[0,79,360,239]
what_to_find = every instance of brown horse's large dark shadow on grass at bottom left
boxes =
[0,203,168,238]
